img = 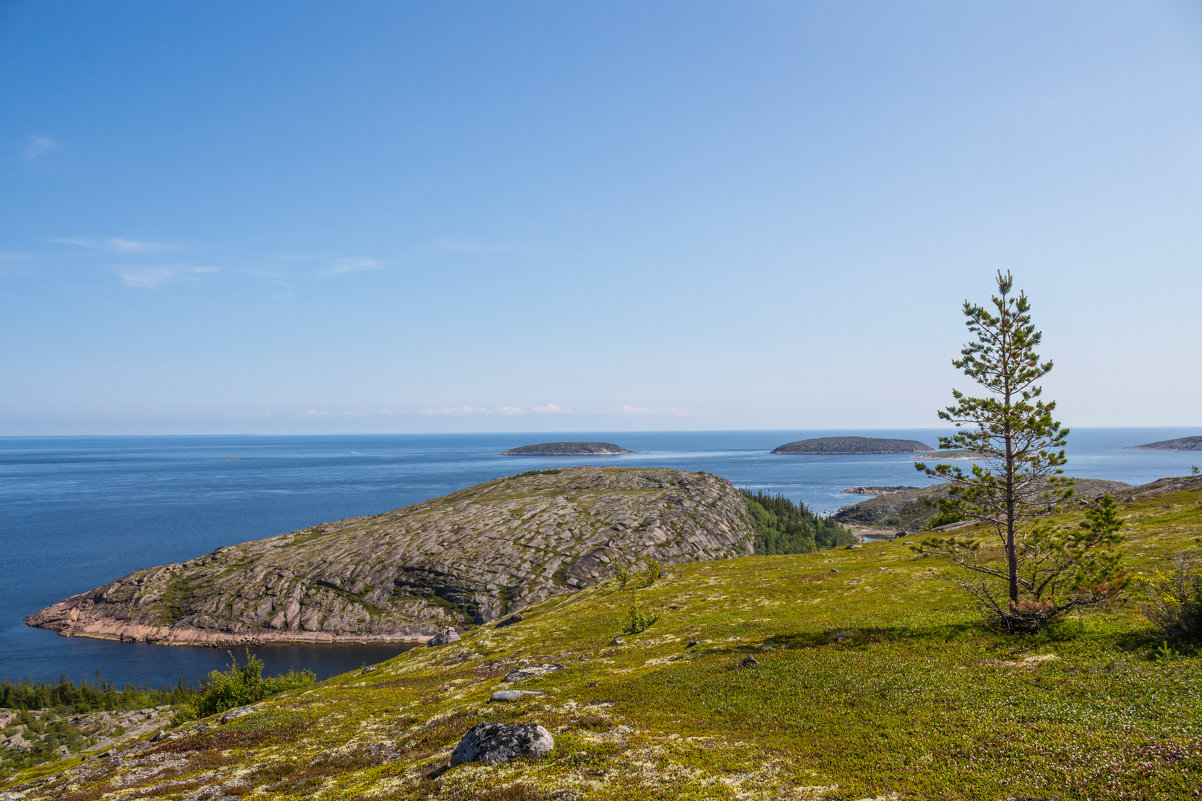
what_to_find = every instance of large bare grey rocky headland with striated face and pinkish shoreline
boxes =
[25,467,754,646]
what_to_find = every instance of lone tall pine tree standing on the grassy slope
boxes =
[915,271,1123,631]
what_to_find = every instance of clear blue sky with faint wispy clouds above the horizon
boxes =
[0,0,1202,435]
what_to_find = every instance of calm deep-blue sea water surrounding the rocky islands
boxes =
[0,428,1202,686]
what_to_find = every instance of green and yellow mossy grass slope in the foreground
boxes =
[9,483,1202,801]
